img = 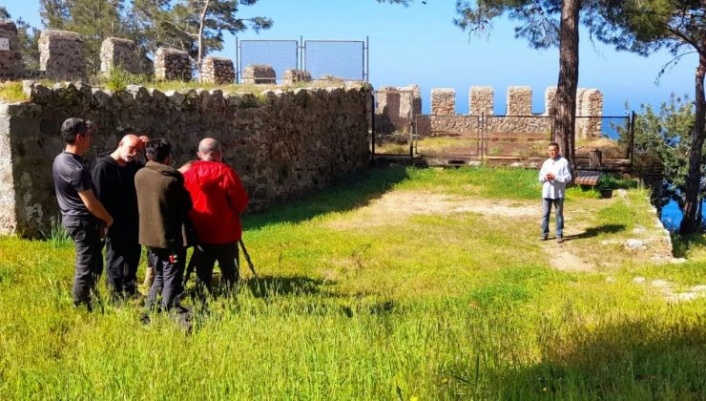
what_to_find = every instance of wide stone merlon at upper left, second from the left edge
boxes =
[39,30,87,80]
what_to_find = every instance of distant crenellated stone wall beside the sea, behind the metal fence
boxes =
[375,86,603,138]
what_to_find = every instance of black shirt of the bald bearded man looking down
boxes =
[91,156,143,238]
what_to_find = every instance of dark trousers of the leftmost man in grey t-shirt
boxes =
[62,216,103,310]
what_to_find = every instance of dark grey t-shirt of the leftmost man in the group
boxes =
[51,152,93,217]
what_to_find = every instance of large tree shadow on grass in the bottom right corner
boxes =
[491,317,706,400]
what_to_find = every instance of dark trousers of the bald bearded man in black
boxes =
[105,232,142,298]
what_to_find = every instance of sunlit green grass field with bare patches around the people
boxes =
[0,168,706,400]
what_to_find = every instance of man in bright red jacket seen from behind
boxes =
[184,138,248,293]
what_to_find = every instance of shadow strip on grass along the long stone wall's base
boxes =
[243,167,408,229]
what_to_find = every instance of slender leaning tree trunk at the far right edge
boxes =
[679,52,706,234]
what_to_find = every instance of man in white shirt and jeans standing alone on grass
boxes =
[539,142,571,243]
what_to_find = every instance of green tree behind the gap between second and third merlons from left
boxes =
[39,0,132,73]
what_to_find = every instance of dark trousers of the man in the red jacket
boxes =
[192,242,238,293]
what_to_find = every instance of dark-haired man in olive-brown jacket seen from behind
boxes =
[135,138,191,313]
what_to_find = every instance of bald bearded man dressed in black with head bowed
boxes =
[92,134,147,300]
